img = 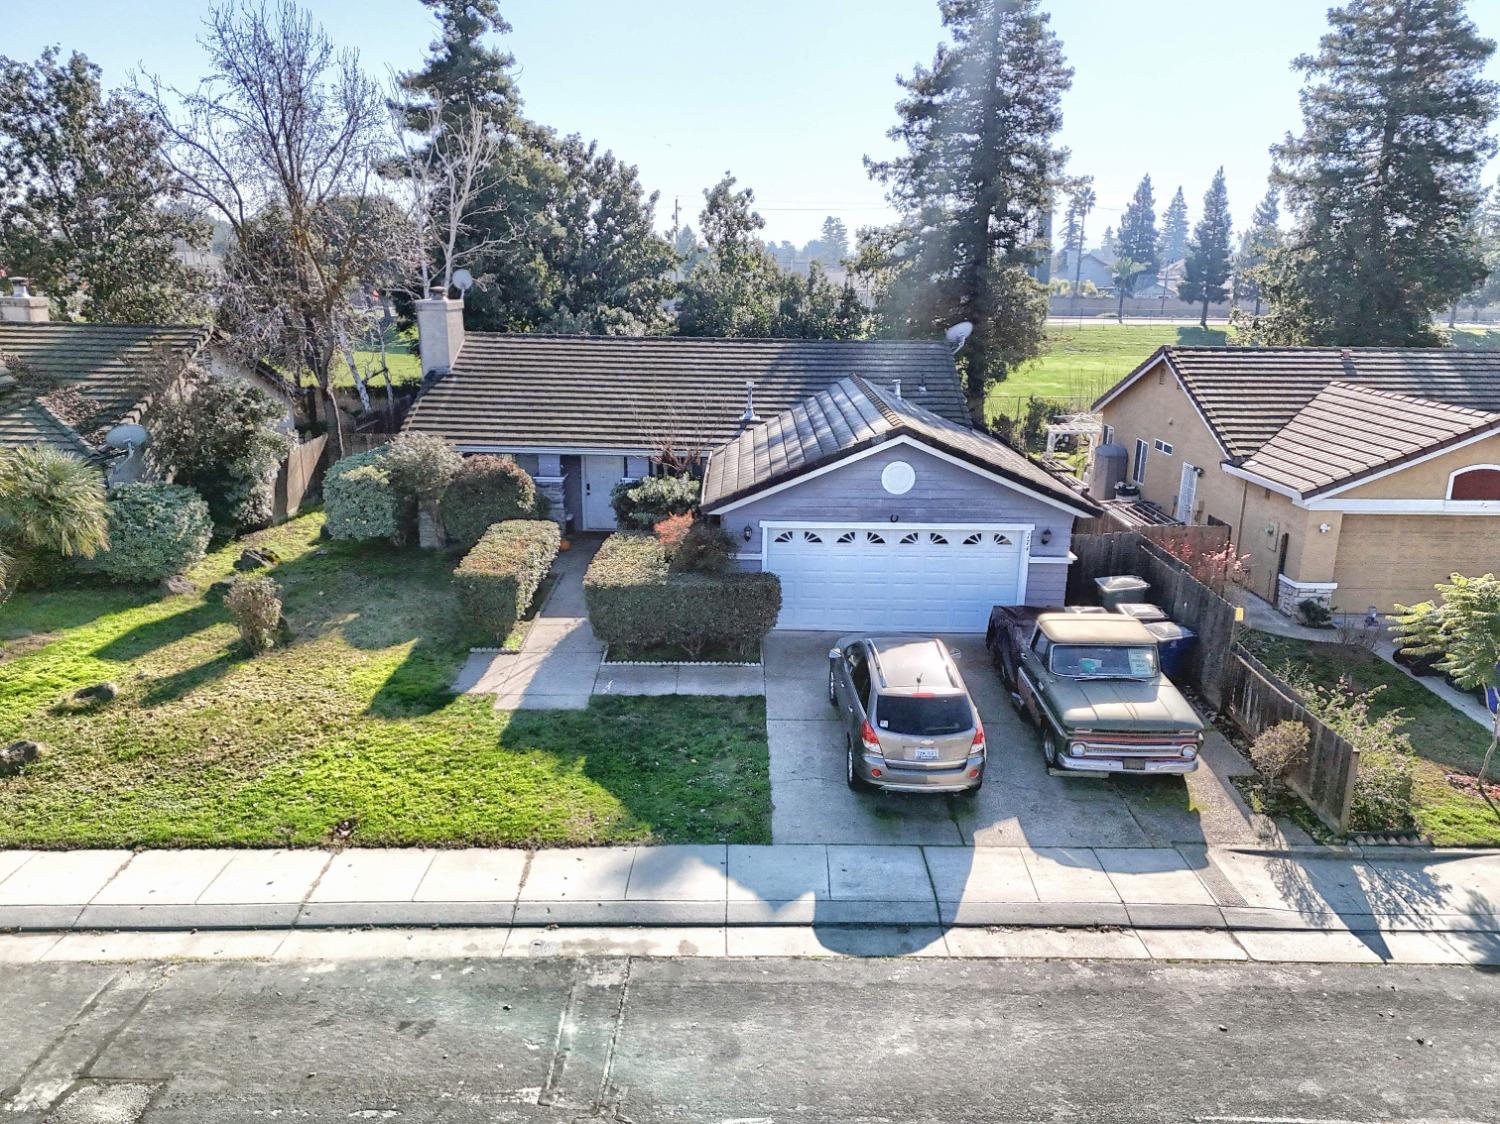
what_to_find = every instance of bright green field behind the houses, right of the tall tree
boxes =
[989,324,1227,417]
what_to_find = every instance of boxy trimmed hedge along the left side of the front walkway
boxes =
[453,519,563,641]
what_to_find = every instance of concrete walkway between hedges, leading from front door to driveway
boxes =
[453,537,765,710]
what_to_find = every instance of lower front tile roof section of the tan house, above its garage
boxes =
[1241,381,1500,495]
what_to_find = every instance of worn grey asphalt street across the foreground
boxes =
[0,957,1500,1124]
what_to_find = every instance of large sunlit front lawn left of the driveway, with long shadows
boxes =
[0,515,771,846]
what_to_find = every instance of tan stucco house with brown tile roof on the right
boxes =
[1094,347,1500,614]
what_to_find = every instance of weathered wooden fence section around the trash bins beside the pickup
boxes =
[1068,527,1239,708]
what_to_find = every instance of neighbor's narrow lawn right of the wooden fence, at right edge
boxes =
[1242,632,1500,846]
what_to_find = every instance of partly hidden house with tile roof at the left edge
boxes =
[0,282,296,483]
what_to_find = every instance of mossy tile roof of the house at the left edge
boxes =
[0,323,209,452]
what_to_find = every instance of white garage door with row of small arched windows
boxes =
[765,524,1029,632]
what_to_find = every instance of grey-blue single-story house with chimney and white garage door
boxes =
[407,300,1100,632]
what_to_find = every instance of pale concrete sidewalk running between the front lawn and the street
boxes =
[0,843,1500,945]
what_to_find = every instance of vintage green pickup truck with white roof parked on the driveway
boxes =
[986,606,1203,773]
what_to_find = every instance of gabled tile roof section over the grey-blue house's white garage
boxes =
[702,378,1100,515]
